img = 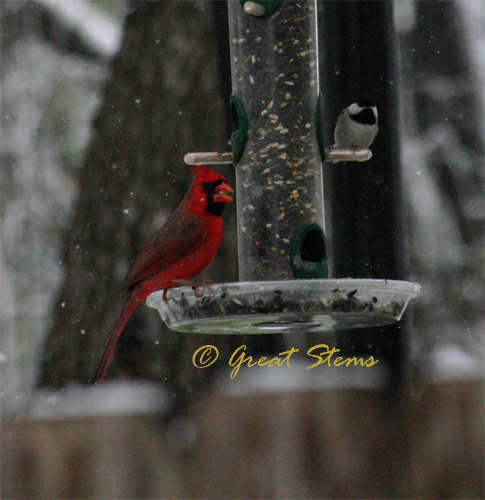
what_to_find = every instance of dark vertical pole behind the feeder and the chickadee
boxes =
[319,1,409,382]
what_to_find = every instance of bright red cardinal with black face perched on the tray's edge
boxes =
[92,166,234,384]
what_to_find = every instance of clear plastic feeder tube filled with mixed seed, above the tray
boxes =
[228,0,325,281]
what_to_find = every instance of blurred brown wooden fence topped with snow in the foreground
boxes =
[2,372,484,499]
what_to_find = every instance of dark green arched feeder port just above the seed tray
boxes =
[290,223,328,279]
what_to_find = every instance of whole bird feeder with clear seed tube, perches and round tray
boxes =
[147,0,420,334]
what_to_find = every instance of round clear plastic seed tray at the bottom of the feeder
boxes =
[147,279,421,335]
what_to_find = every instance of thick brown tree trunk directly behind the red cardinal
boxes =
[38,1,236,387]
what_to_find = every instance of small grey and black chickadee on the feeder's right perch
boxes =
[332,95,378,149]
